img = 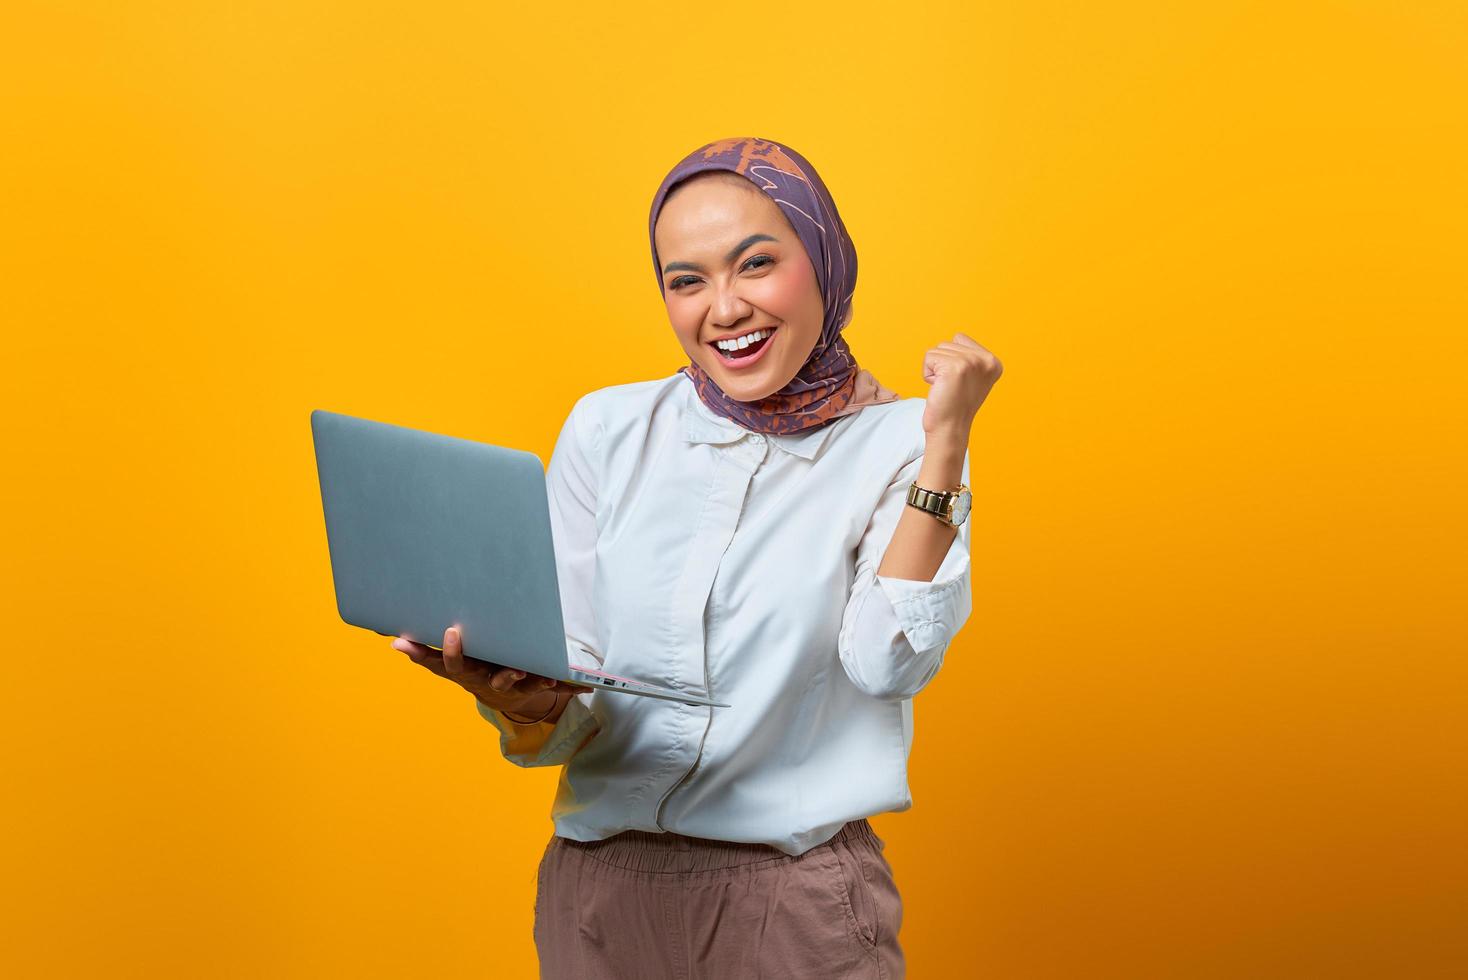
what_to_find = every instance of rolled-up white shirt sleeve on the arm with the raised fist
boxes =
[838,452,973,701]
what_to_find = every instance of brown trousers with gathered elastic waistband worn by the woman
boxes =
[534,820,906,980]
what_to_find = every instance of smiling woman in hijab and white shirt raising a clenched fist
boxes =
[393,138,1001,980]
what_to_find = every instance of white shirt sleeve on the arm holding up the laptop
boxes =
[474,396,603,767]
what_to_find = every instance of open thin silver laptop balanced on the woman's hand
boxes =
[311,409,730,707]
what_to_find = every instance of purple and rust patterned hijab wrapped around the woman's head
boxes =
[647,136,898,433]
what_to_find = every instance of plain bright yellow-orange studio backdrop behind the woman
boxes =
[0,0,1468,980]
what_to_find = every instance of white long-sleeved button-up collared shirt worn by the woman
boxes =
[476,371,972,854]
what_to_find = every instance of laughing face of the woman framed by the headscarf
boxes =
[653,175,825,402]
